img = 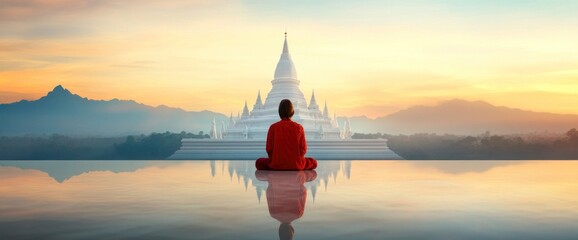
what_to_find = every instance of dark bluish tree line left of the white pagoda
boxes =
[0,131,209,160]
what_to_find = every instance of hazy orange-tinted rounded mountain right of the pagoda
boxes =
[349,99,578,134]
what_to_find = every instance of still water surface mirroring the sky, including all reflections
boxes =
[0,161,578,239]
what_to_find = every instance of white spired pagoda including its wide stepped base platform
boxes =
[169,33,401,160]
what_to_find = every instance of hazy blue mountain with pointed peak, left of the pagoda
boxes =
[0,85,228,136]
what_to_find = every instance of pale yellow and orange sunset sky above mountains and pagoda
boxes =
[0,0,578,118]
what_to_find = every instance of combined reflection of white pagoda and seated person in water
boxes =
[209,161,351,239]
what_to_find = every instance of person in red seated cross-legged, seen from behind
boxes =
[255,99,317,170]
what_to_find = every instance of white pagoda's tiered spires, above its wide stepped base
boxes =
[223,33,342,140]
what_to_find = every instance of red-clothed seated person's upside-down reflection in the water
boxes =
[255,170,317,239]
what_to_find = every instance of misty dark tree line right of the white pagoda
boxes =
[352,128,578,160]
